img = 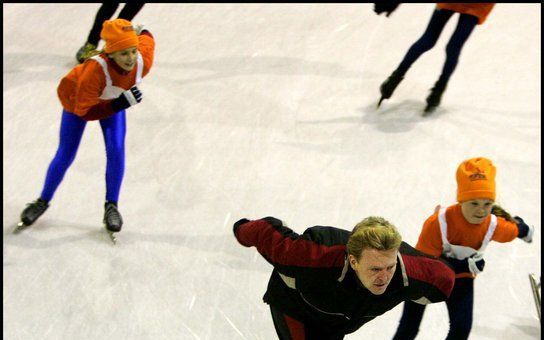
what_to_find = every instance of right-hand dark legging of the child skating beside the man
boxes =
[446,278,474,340]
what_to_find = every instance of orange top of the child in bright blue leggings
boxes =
[57,34,155,117]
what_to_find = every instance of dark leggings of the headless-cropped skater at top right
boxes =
[397,9,478,87]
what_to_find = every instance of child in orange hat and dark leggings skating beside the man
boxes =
[394,157,534,340]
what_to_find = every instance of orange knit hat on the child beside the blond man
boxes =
[456,157,496,202]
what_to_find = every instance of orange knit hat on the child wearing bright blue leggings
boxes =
[100,19,138,53]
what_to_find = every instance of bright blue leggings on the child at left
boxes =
[40,110,127,202]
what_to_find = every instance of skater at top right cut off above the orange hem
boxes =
[378,3,495,112]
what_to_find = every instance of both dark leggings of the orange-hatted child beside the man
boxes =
[393,278,474,340]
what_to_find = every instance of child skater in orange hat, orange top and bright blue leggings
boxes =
[21,19,155,232]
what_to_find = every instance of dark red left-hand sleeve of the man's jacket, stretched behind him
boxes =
[235,217,346,268]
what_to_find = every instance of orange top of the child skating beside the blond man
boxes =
[415,204,519,277]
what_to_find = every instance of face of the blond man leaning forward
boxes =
[349,249,398,295]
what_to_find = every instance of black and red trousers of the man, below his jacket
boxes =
[270,306,344,340]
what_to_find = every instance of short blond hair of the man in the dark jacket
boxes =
[347,216,402,260]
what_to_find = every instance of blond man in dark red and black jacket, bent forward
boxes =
[233,217,455,340]
